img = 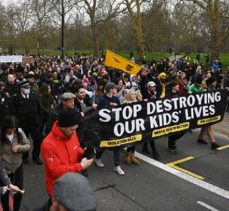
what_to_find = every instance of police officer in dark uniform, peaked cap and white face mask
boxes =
[13,81,42,165]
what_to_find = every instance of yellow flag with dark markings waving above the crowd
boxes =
[105,50,142,74]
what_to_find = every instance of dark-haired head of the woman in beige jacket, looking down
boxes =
[1,116,21,142]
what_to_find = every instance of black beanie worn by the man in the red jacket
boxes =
[58,109,81,127]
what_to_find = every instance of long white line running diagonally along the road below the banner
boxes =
[135,152,229,199]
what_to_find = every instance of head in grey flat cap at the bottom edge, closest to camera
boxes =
[51,173,96,211]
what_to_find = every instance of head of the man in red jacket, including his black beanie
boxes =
[58,109,81,138]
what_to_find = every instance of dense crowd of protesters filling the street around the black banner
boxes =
[0,56,229,210]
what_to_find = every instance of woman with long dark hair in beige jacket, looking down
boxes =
[0,116,30,211]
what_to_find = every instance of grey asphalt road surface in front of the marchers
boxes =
[17,130,229,211]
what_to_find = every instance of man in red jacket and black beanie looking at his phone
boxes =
[41,109,93,196]
